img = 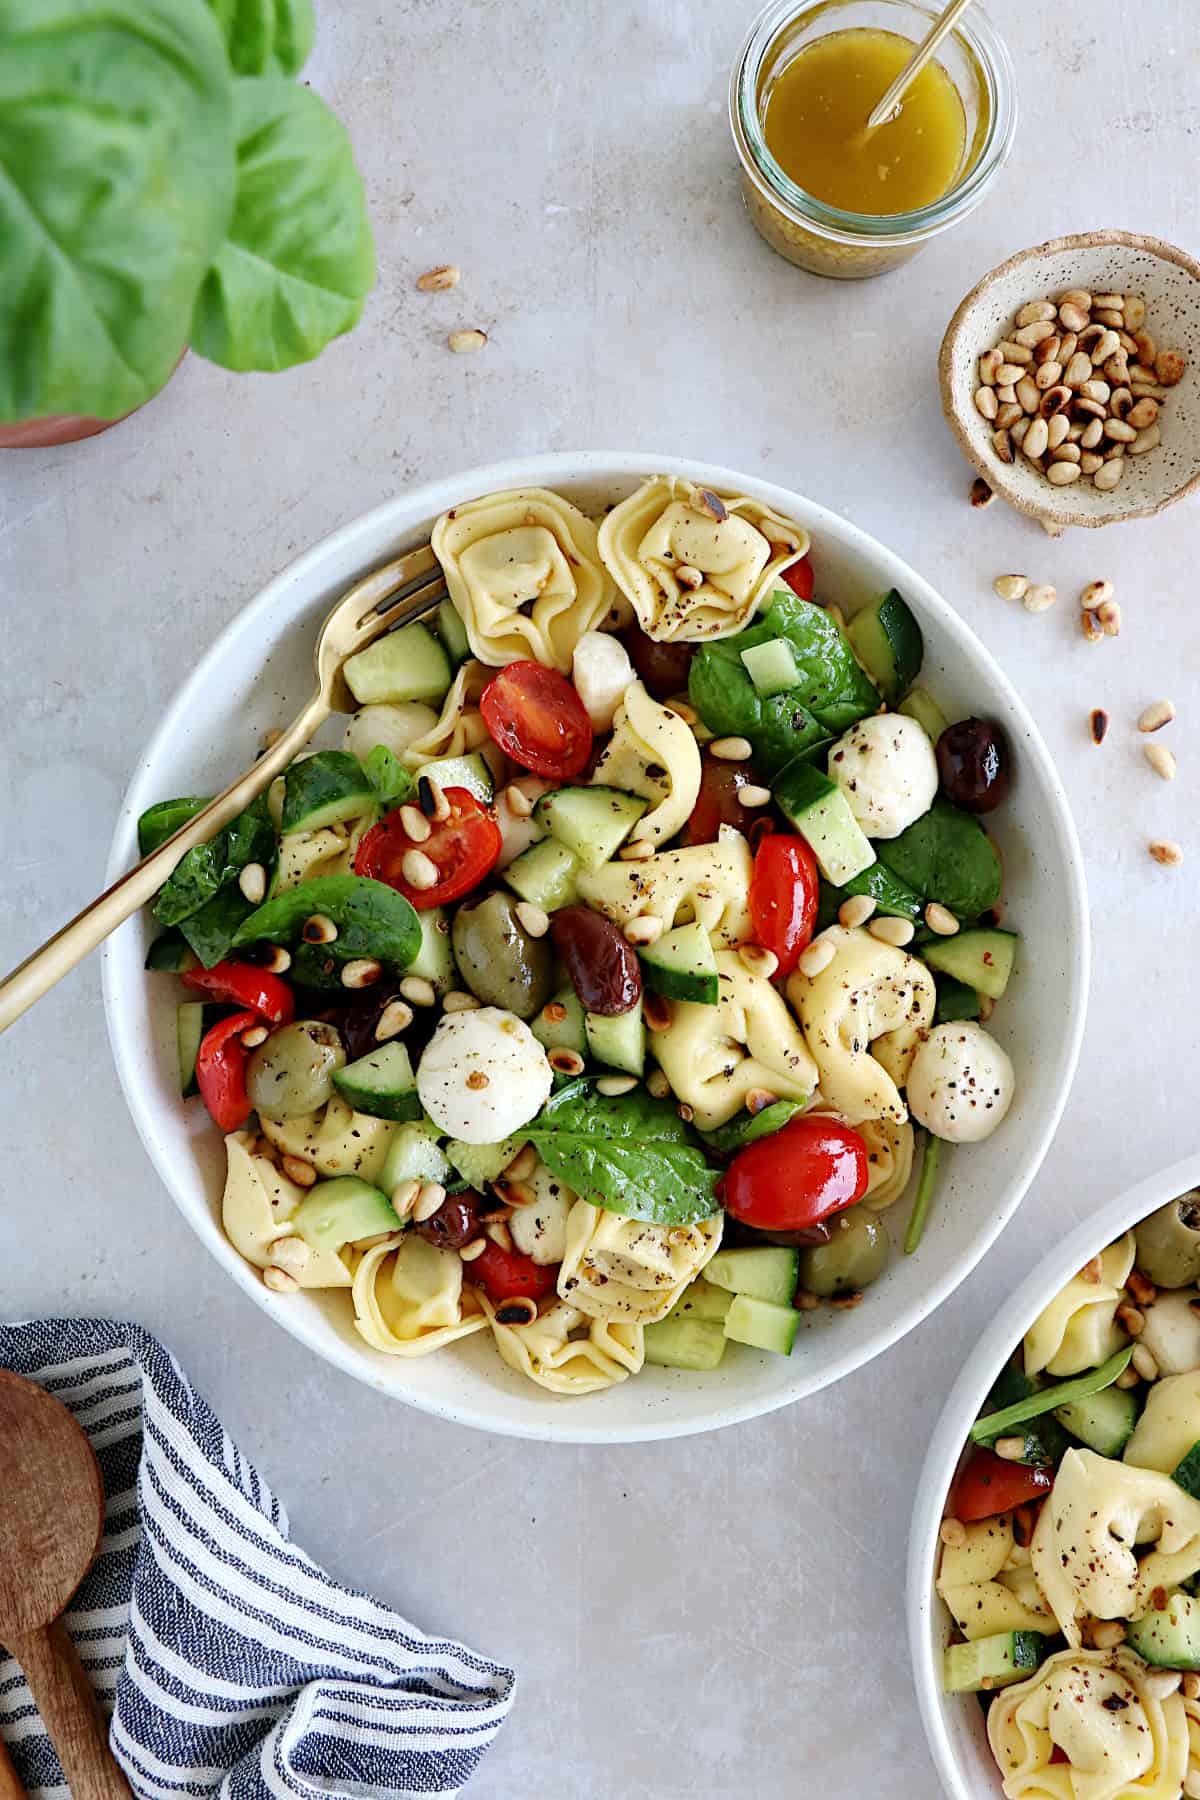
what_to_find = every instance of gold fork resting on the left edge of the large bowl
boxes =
[0,544,446,1031]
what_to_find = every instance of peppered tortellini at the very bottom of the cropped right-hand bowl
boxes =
[988,1649,1189,1800]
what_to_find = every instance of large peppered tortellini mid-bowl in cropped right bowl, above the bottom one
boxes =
[1033,1449,1200,1647]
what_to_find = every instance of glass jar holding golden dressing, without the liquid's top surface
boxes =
[729,0,1016,281]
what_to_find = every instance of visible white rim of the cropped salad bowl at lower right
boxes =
[907,1152,1200,1800]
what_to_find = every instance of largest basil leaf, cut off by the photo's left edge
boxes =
[0,0,234,419]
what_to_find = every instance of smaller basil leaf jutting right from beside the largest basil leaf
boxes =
[193,76,374,369]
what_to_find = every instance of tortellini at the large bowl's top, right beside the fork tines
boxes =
[430,488,613,675]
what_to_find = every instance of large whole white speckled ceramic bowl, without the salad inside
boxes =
[104,452,1088,1442]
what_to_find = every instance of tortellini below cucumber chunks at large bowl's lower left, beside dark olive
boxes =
[354,1231,488,1355]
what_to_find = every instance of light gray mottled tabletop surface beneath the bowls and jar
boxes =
[0,0,1200,1800]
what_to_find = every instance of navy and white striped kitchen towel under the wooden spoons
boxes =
[0,1319,515,1800]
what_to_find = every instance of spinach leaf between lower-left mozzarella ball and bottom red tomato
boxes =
[524,1080,721,1226]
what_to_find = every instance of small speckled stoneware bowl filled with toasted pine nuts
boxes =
[937,230,1200,531]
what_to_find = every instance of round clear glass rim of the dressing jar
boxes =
[729,0,1016,245]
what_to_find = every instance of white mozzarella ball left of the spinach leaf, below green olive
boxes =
[417,1006,554,1143]
